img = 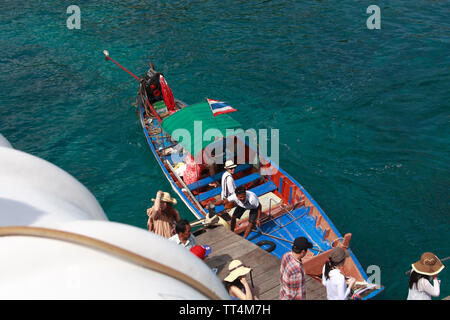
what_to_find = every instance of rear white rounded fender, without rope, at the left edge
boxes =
[0,141,107,226]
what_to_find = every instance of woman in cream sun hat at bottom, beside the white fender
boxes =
[223,260,254,300]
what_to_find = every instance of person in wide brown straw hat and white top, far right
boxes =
[407,252,444,300]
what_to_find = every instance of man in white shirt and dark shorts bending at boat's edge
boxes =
[215,186,261,238]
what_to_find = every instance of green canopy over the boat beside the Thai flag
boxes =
[161,102,242,155]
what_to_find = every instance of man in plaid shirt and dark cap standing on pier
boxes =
[280,237,313,300]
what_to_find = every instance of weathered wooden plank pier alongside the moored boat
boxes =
[194,226,326,300]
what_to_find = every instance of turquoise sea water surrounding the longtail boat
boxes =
[0,0,450,299]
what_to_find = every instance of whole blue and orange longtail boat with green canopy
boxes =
[105,52,384,300]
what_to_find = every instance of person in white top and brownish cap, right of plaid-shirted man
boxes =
[322,247,355,300]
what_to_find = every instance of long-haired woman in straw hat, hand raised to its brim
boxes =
[147,190,181,238]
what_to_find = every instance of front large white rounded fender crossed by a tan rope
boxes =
[0,220,229,300]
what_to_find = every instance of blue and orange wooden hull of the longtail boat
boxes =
[137,95,384,300]
